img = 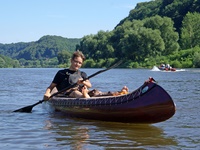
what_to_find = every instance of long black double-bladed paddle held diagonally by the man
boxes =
[13,60,122,113]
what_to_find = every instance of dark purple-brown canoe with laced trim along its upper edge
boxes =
[47,78,176,124]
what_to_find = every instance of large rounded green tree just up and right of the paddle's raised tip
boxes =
[120,27,164,61]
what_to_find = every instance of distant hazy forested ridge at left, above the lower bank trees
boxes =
[0,35,80,60]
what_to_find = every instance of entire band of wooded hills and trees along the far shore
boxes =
[0,0,200,68]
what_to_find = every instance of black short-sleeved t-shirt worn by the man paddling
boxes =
[52,69,87,91]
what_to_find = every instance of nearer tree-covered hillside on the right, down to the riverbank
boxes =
[80,0,200,68]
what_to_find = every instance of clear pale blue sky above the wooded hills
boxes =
[0,0,149,44]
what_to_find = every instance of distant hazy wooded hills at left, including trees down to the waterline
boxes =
[0,35,81,68]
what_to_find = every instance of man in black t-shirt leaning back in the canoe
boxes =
[43,51,92,100]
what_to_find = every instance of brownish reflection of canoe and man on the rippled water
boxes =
[46,113,177,149]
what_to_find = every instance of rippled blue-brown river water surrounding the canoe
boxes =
[0,67,200,150]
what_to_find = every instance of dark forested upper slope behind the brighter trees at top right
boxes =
[117,0,200,33]
